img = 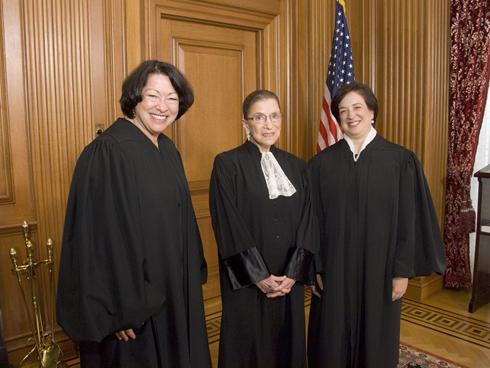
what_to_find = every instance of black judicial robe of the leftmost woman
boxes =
[57,119,211,368]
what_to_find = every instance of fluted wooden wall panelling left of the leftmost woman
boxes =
[0,0,126,364]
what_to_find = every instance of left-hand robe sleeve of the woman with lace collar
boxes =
[209,155,270,290]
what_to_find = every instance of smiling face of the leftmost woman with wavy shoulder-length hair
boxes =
[132,74,179,143]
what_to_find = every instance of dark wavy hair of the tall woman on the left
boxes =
[119,60,194,119]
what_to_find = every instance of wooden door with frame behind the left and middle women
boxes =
[145,1,287,314]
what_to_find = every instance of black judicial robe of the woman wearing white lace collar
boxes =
[210,142,318,368]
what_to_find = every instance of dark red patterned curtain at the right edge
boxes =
[444,0,490,288]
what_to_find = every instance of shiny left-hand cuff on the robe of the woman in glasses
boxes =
[223,247,270,290]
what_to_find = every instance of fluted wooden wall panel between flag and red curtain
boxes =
[372,0,449,225]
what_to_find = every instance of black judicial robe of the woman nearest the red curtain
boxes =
[308,136,445,368]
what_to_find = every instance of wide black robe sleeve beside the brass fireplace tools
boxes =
[57,136,165,341]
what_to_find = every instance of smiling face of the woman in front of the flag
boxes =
[339,91,374,139]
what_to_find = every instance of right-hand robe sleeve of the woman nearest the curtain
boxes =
[393,153,446,278]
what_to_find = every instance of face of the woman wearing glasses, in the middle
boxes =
[243,98,281,152]
